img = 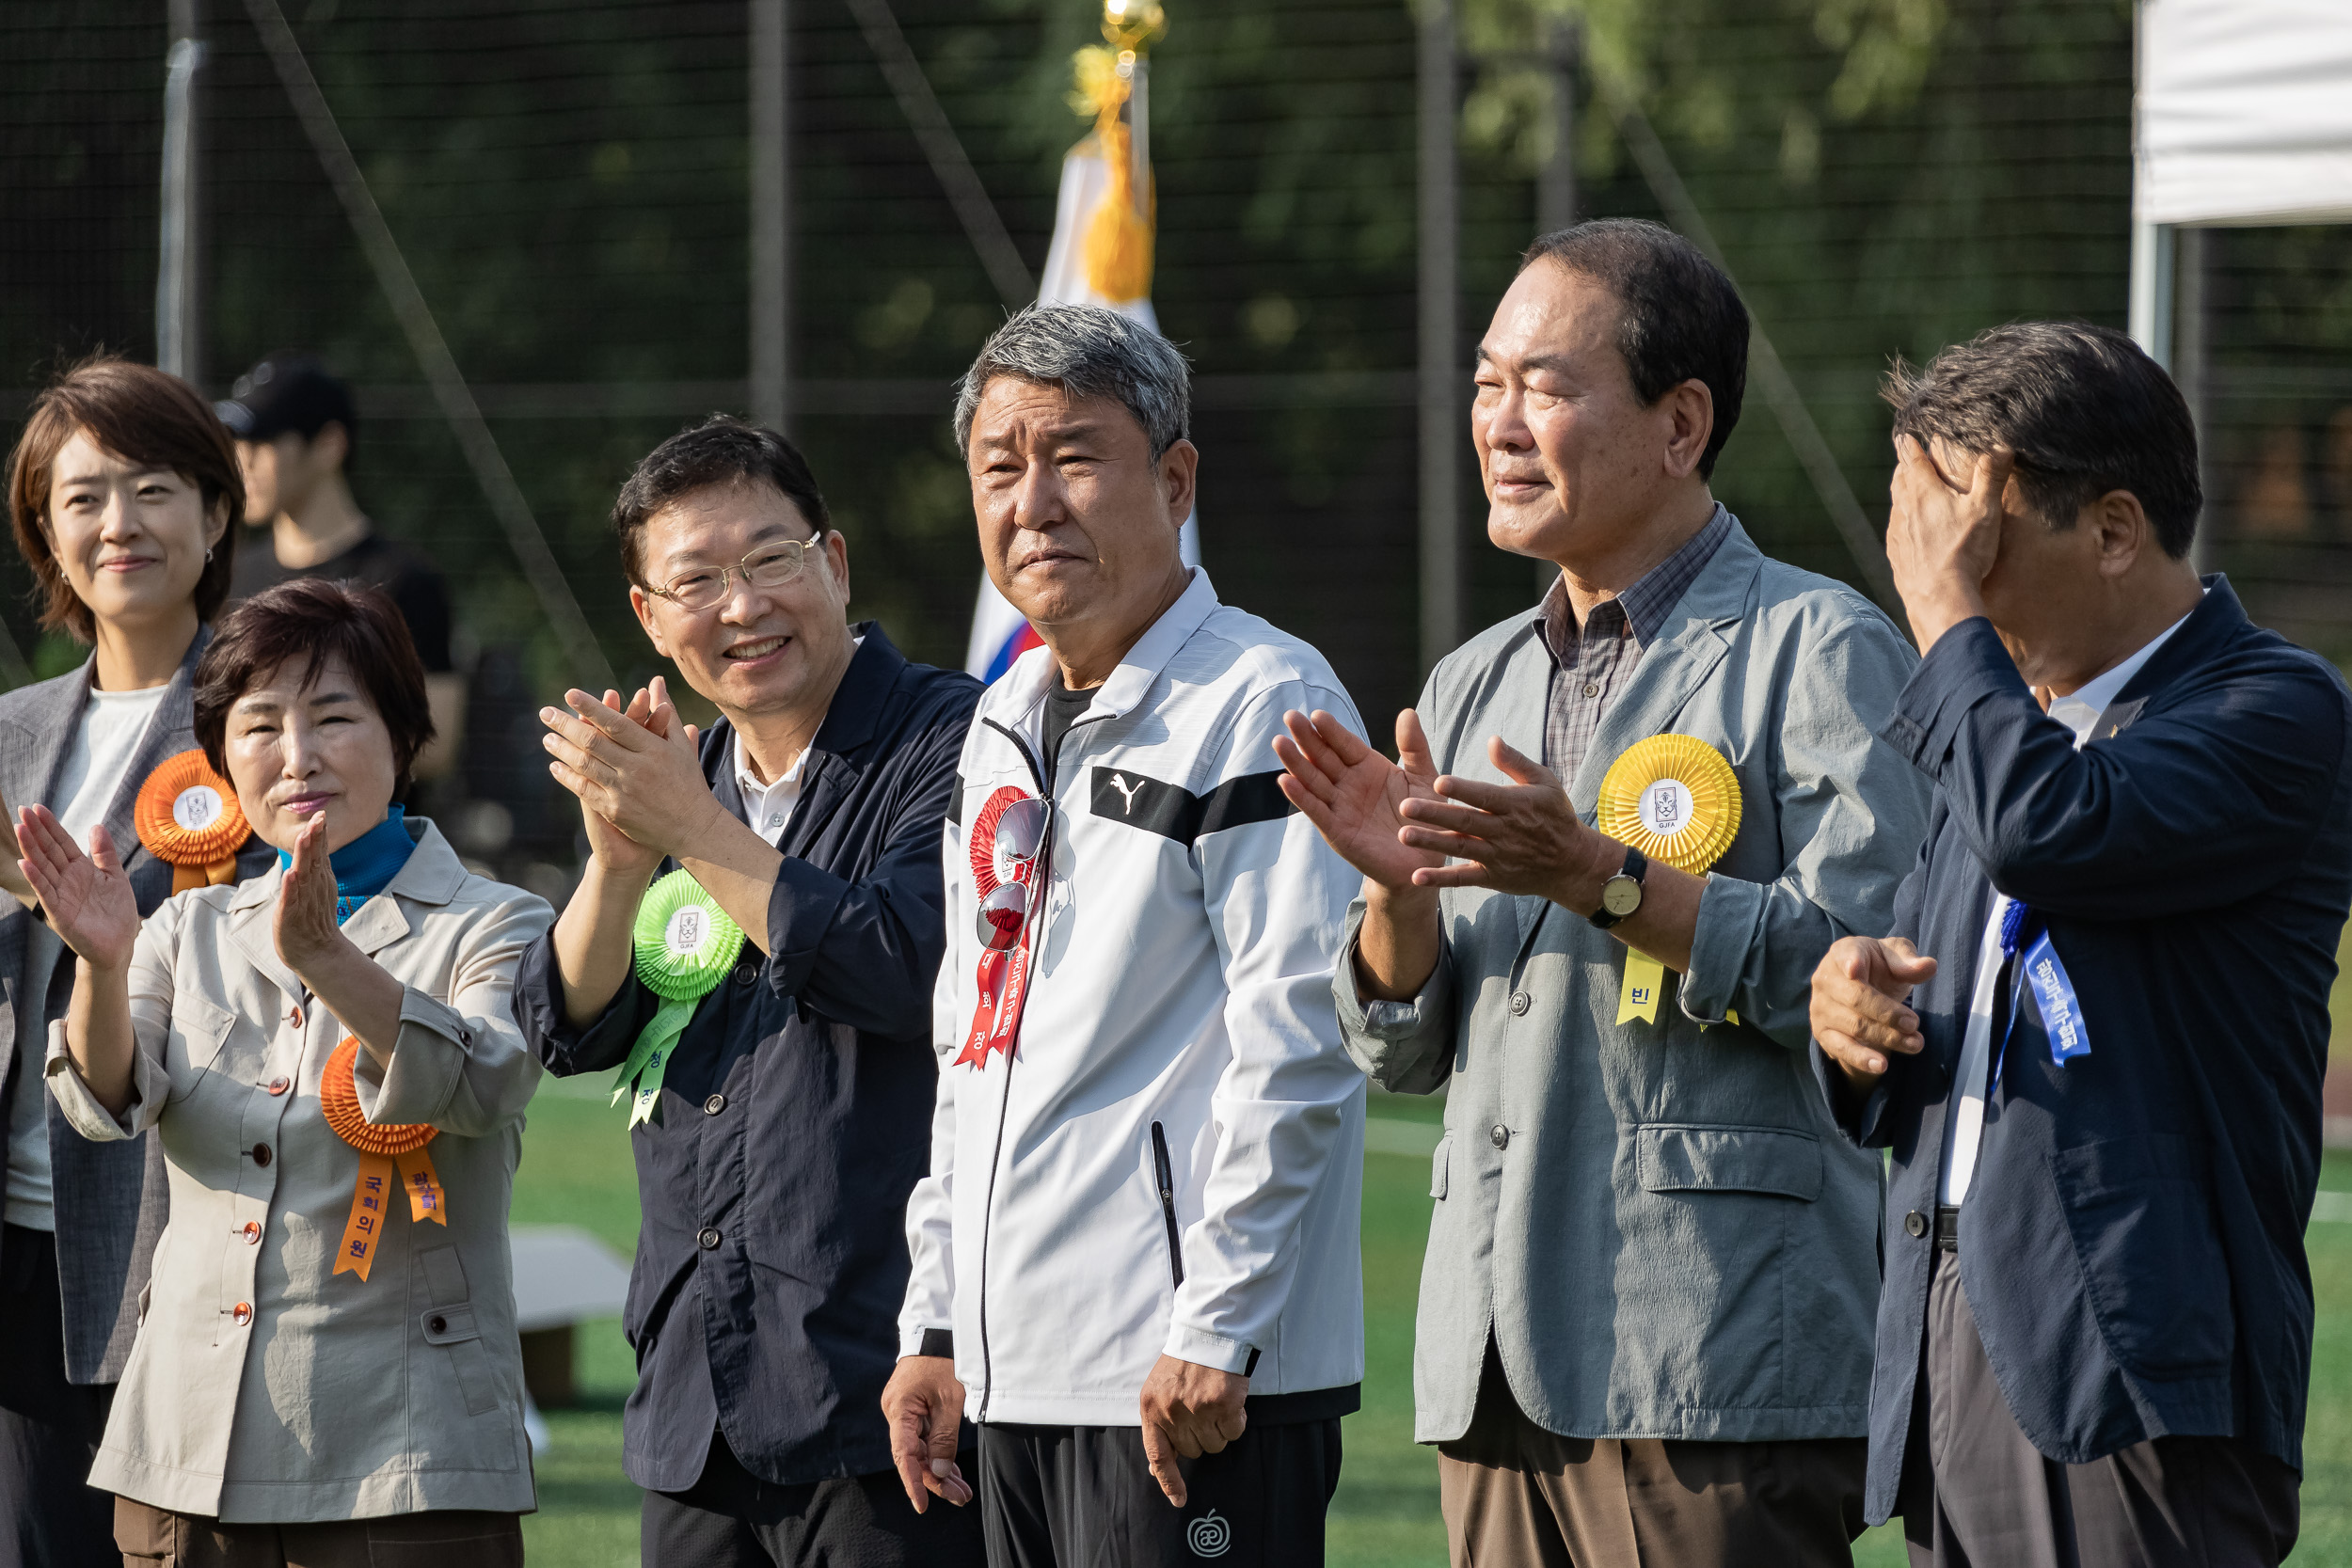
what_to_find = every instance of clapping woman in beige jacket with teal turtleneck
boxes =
[17,580,550,1568]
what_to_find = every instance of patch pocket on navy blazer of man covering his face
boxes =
[2051,1135,2237,1380]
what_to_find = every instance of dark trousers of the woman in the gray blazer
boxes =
[0,1225,118,1568]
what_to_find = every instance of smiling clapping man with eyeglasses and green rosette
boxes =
[516,419,981,1568]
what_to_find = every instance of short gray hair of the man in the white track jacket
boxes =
[955,303,1193,461]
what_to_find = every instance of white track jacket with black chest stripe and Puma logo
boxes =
[898,569,1364,1427]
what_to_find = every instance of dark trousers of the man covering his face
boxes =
[1899,1251,2303,1568]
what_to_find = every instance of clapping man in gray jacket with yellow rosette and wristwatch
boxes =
[1278,221,1927,1568]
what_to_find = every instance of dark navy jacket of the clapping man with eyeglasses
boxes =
[516,623,981,1493]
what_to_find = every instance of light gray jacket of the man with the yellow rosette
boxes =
[1334,529,1927,1444]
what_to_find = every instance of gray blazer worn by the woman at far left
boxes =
[0,627,278,1383]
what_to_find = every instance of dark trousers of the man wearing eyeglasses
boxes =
[638,1432,981,1568]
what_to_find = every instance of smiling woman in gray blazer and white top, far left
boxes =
[0,357,273,1568]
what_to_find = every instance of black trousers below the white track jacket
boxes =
[978,1416,1339,1568]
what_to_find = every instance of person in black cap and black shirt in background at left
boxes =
[215,353,466,778]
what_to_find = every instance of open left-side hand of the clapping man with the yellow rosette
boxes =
[1275,707,1447,889]
